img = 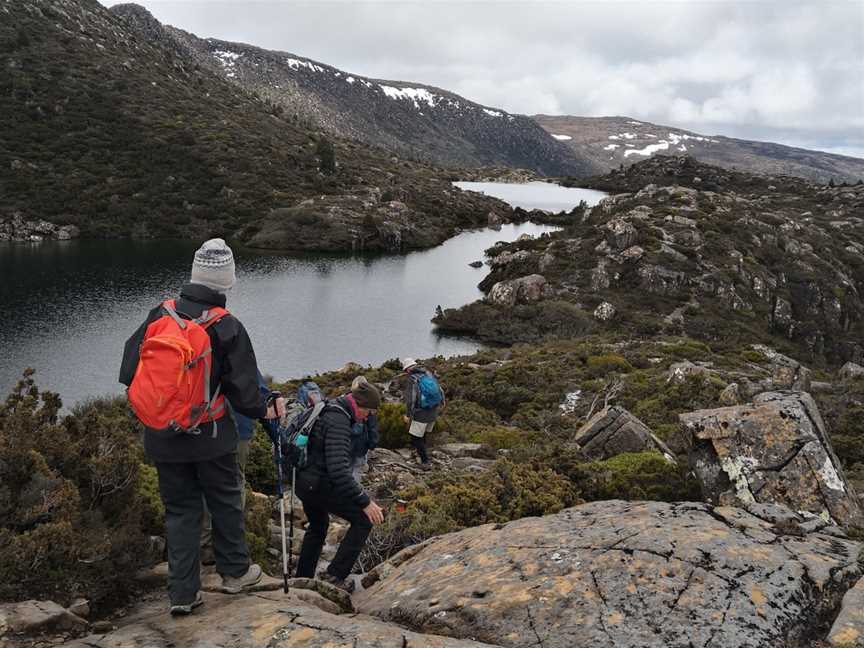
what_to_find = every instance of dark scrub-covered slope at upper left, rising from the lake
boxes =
[0,0,501,250]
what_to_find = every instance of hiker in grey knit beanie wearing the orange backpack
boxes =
[120,239,285,615]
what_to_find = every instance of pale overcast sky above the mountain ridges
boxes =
[101,0,864,157]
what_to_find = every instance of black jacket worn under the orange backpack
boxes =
[120,284,267,462]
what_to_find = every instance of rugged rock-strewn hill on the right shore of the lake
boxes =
[450,157,864,364]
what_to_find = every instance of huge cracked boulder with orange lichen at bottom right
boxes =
[354,501,862,648]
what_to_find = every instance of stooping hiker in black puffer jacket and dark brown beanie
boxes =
[295,382,384,590]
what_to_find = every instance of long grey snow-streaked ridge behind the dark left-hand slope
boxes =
[112,4,601,176]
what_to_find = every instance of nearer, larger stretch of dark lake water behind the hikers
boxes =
[0,185,608,404]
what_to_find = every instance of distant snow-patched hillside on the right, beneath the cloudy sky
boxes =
[534,115,864,184]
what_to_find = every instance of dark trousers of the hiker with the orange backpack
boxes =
[156,453,249,605]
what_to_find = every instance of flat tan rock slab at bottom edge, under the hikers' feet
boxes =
[66,591,492,648]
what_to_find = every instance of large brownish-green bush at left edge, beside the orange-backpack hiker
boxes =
[0,372,154,606]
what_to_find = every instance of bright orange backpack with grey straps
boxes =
[127,300,228,437]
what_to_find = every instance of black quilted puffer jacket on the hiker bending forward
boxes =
[298,397,371,508]
